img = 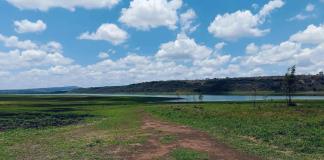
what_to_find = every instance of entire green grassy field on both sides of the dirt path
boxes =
[0,96,324,160]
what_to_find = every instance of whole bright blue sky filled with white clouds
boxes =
[0,0,324,89]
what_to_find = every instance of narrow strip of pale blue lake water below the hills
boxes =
[58,94,324,102]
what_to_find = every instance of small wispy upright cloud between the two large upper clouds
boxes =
[180,9,199,33]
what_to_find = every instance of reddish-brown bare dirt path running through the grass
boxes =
[131,115,259,160]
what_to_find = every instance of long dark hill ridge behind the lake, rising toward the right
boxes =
[72,75,324,94]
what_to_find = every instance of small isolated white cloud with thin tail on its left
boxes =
[79,23,128,45]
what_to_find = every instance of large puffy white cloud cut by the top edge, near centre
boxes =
[119,0,182,30]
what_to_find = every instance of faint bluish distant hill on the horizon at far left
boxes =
[0,86,79,94]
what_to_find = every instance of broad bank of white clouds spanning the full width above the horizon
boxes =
[0,25,324,88]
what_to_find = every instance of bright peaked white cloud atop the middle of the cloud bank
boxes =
[156,34,212,61]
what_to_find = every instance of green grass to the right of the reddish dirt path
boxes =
[147,101,324,160]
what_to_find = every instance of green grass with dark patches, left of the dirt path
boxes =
[0,96,160,160]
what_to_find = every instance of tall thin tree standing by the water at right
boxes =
[284,65,296,106]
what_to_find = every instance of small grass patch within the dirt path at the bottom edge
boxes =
[170,148,208,160]
